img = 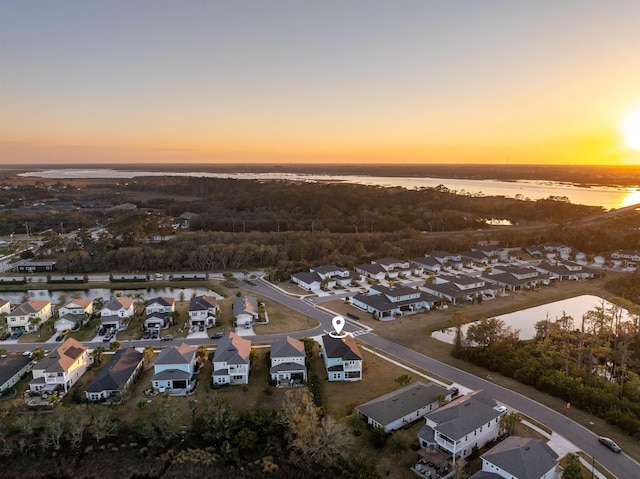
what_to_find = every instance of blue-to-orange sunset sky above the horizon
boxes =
[0,0,640,164]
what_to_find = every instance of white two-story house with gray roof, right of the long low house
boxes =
[418,391,502,459]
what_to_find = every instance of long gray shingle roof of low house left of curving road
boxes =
[356,382,451,425]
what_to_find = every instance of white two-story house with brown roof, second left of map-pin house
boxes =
[211,333,251,386]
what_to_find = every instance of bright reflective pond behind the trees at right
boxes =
[431,294,631,344]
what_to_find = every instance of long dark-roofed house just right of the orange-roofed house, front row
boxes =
[84,348,143,403]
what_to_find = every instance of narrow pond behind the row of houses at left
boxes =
[0,287,222,305]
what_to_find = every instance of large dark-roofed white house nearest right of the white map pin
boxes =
[351,285,438,321]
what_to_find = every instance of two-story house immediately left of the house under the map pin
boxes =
[269,336,307,387]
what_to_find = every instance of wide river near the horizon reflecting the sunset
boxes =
[20,168,640,210]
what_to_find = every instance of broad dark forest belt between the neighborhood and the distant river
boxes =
[5,177,640,277]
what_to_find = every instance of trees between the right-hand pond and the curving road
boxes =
[453,306,640,438]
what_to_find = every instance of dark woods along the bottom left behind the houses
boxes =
[0,389,378,479]
